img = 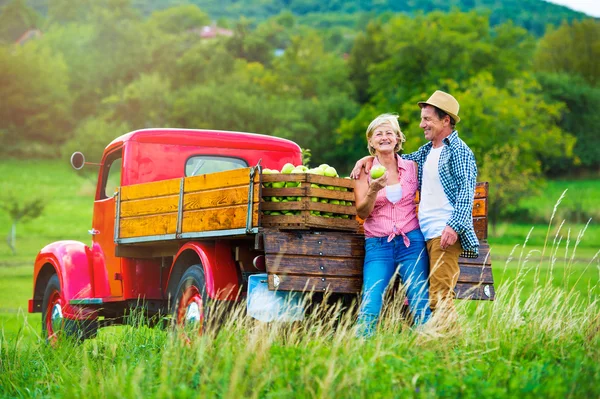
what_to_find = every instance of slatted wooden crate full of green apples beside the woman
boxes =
[260,163,359,231]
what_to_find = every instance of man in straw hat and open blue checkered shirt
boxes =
[352,90,479,321]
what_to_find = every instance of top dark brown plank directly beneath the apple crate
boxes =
[263,229,365,258]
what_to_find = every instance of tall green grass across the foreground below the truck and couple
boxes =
[0,234,600,398]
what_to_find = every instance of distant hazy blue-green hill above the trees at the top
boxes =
[0,0,591,36]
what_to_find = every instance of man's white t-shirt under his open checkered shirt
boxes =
[419,146,454,240]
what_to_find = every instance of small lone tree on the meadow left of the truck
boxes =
[0,193,46,255]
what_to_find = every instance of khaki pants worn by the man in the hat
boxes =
[427,237,462,319]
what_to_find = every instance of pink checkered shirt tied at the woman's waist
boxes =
[364,156,419,247]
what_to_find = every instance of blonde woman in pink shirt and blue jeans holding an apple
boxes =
[355,114,431,337]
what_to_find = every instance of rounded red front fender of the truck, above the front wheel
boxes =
[29,241,95,319]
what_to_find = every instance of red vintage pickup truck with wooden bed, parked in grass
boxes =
[29,129,494,342]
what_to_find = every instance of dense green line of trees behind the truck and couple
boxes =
[0,0,600,225]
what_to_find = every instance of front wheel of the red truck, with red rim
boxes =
[42,274,98,345]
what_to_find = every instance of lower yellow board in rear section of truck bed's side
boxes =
[182,205,258,233]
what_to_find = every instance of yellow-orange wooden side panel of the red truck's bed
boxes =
[115,168,260,243]
